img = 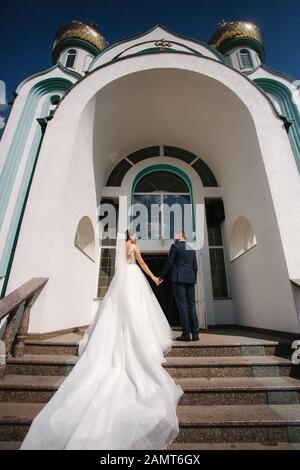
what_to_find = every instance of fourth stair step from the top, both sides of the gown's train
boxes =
[0,403,300,444]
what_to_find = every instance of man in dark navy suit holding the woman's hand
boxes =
[159,230,199,341]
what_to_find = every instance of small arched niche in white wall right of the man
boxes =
[230,216,257,261]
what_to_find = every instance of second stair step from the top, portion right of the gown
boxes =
[164,356,299,378]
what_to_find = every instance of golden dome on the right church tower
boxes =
[209,20,264,52]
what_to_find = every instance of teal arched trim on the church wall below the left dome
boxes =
[0,78,73,284]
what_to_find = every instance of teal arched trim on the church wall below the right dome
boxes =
[253,78,300,173]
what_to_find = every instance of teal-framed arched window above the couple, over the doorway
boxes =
[131,169,193,240]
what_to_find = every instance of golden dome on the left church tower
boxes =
[53,21,108,51]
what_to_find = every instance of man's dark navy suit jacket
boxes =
[159,240,198,284]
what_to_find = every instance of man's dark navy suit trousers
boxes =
[172,282,199,336]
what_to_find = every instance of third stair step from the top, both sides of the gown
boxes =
[0,375,300,406]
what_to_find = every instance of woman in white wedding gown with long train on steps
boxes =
[21,230,183,450]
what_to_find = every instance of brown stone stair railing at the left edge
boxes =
[0,277,48,378]
